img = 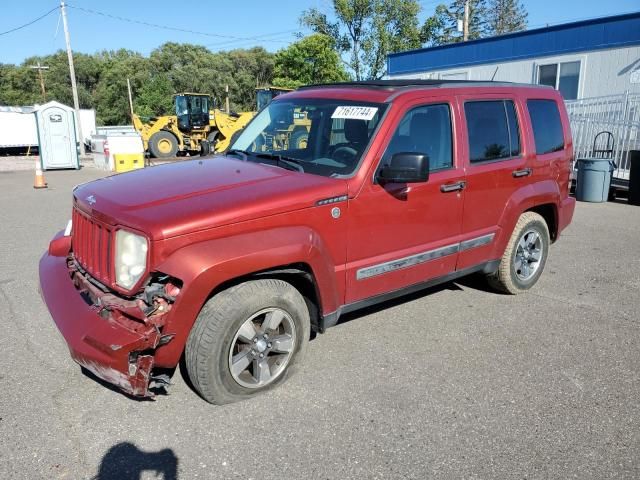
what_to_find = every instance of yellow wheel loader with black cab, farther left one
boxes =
[132,93,254,158]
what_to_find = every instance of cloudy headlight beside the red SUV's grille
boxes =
[115,230,149,290]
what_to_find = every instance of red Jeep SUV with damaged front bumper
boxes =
[40,80,575,404]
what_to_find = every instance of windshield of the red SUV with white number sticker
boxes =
[228,98,387,177]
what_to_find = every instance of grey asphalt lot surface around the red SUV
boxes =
[0,168,640,480]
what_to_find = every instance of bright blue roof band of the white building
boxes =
[387,12,640,75]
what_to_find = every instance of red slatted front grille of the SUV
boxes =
[71,208,113,285]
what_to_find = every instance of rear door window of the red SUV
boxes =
[464,100,520,163]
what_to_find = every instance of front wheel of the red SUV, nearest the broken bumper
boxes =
[185,279,310,405]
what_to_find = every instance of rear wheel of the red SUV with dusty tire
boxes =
[487,212,551,295]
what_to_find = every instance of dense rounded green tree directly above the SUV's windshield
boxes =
[273,33,349,88]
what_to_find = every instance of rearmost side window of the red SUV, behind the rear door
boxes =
[527,100,564,155]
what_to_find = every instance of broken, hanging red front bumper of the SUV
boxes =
[40,236,171,397]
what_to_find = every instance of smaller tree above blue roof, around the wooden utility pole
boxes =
[422,0,487,45]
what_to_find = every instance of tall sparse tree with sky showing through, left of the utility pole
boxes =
[300,0,421,80]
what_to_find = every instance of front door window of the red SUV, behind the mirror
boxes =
[382,104,453,171]
